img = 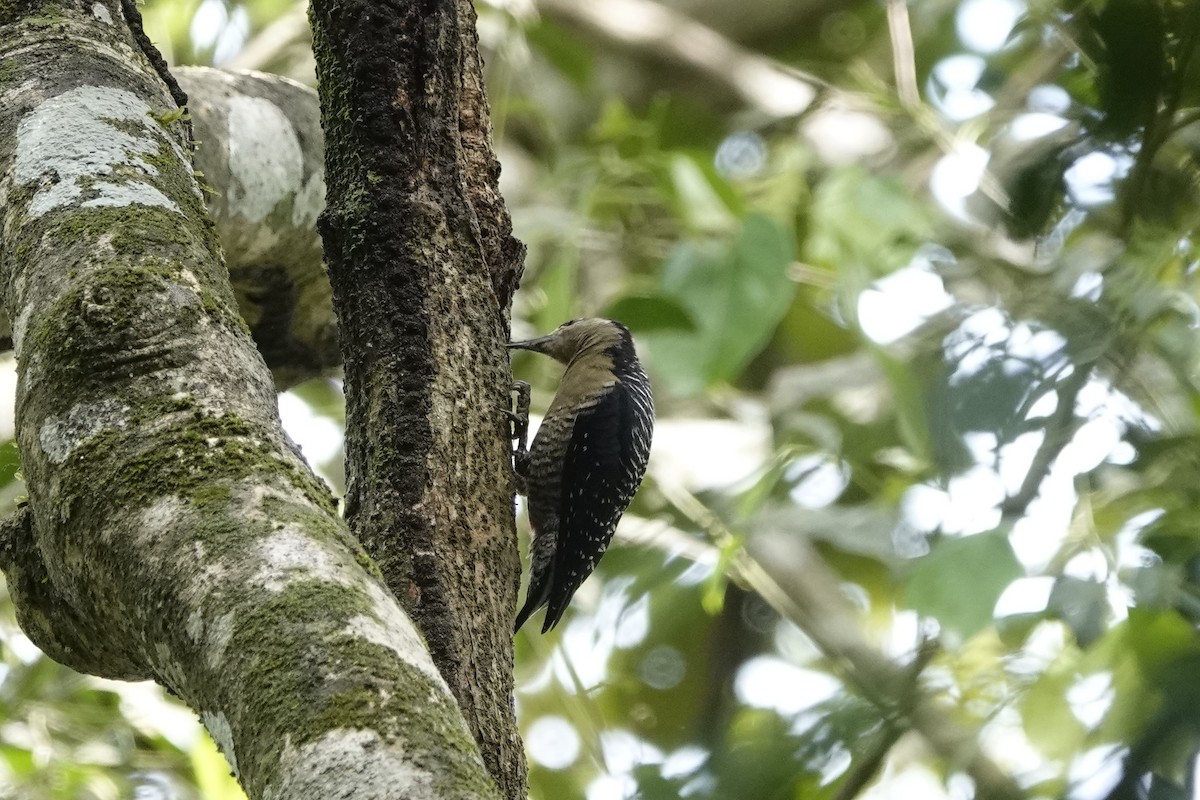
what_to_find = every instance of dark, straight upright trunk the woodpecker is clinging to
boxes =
[311,0,526,798]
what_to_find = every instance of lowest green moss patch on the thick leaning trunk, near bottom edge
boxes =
[228,581,491,796]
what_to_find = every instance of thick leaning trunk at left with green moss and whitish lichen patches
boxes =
[0,0,496,799]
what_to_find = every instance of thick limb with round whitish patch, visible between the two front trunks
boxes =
[175,67,342,389]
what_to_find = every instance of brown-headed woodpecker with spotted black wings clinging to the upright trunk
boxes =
[508,319,654,633]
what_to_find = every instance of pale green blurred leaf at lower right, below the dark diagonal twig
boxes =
[905,531,1021,638]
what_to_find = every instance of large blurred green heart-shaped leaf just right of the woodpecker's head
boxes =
[646,213,796,395]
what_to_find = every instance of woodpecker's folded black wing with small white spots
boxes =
[542,383,649,633]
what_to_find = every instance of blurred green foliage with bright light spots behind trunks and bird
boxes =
[11,0,1200,800]
